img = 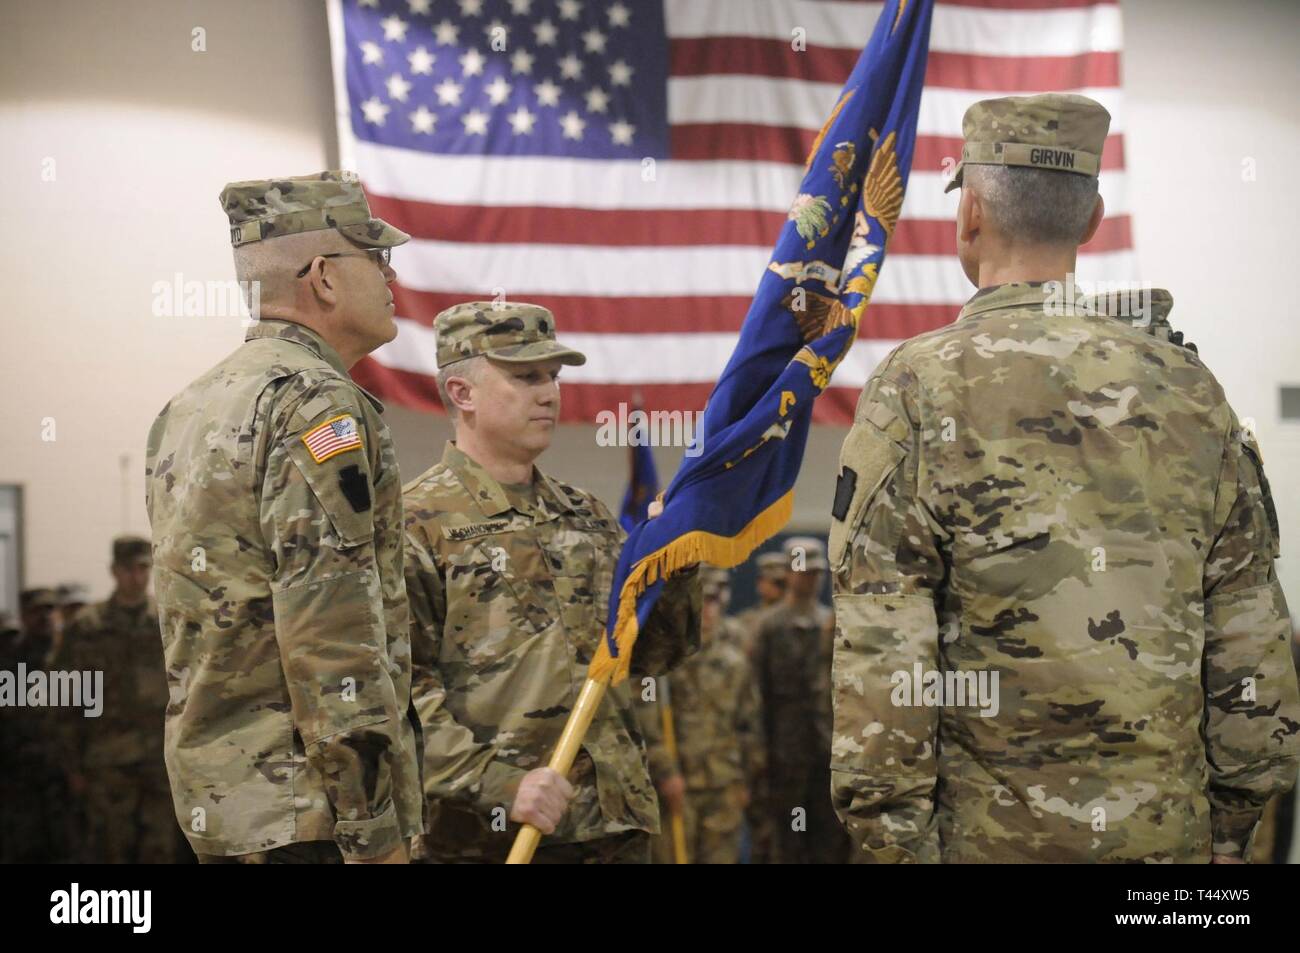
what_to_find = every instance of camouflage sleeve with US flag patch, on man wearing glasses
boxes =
[260,378,404,859]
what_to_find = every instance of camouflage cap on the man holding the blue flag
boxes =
[433,302,586,369]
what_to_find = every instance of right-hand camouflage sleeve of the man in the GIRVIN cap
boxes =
[1203,416,1300,857]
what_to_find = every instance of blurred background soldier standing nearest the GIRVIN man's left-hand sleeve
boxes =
[753,536,849,863]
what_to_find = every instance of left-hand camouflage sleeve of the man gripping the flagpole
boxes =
[406,524,527,815]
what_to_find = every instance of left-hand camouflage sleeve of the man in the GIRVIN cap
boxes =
[829,361,944,863]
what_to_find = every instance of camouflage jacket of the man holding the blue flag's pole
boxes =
[406,443,699,862]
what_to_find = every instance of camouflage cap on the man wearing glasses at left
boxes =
[221,170,411,248]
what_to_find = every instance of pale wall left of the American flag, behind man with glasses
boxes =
[0,0,334,597]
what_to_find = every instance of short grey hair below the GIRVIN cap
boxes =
[962,165,1097,244]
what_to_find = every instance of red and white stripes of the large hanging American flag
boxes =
[333,0,1138,424]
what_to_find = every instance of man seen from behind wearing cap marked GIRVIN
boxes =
[829,95,1300,863]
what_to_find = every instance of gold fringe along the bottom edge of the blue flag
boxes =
[586,490,794,685]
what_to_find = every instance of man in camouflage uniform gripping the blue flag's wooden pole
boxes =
[406,302,699,863]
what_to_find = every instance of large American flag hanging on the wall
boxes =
[330,0,1138,424]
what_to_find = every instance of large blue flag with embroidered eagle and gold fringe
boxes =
[589,0,933,684]
